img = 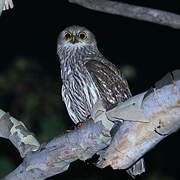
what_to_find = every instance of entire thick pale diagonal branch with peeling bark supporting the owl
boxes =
[0,70,180,180]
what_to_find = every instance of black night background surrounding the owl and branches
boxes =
[0,0,180,180]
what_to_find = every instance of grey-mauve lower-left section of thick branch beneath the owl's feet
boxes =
[5,120,111,180]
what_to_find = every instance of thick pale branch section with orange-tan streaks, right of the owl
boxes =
[99,70,180,169]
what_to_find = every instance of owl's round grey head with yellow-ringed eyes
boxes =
[57,25,96,52]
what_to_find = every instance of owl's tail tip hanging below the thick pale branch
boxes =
[127,158,145,178]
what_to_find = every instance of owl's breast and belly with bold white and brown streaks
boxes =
[61,59,100,123]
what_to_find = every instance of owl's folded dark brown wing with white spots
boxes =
[85,60,131,109]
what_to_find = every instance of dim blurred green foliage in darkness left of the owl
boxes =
[0,57,67,142]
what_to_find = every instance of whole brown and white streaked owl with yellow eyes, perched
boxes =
[57,26,144,176]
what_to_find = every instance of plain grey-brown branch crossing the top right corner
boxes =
[68,0,180,29]
